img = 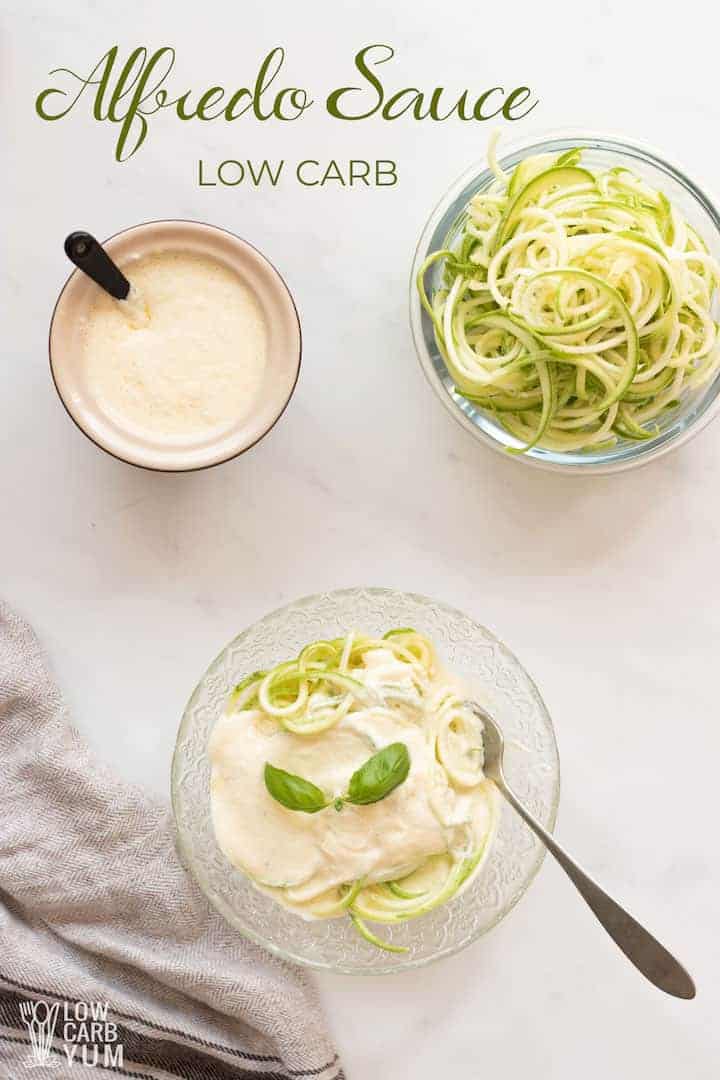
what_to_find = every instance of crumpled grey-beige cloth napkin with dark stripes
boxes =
[0,604,342,1080]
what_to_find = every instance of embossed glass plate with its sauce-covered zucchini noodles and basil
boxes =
[173,589,558,973]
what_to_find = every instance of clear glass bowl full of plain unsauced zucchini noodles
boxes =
[411,127,720,472]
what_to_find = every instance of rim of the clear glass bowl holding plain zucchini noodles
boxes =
[409,126,720,476]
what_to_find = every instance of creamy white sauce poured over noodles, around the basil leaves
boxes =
[209,649,493,906]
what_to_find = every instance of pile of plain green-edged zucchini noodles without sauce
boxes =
[418,143,720,453]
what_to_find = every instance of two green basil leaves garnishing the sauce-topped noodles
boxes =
[264,743,410,813]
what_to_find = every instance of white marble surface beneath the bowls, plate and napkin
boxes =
[0,0,720,1080]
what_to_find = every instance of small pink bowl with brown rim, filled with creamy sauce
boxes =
[50,220,301,472]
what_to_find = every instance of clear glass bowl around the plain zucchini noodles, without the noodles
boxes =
[410,130,720,475]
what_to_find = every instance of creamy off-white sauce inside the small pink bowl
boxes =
[82,252,268,443]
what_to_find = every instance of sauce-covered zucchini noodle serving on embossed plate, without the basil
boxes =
[209,627,498,951]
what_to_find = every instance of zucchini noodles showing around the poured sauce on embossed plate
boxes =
[222,627,498,951]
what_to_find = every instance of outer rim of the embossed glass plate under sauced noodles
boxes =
[171,585,560,975]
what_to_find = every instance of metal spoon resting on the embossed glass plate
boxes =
[466,701,695,999]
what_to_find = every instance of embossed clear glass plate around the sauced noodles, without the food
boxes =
[173,589,559,975]
